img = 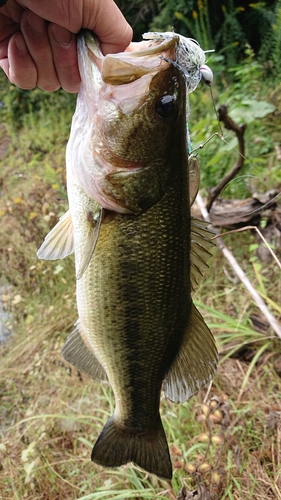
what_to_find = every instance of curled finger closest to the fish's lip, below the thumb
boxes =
[48,23,81,92]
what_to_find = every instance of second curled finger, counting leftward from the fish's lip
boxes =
[21,10,60,92]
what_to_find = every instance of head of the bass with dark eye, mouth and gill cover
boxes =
[73,31,186,214]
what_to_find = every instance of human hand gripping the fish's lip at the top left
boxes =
[0,0,132,92]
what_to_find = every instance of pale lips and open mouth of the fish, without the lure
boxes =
[78,30,180,85]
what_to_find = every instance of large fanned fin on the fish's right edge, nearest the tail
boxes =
[164,303,218,403]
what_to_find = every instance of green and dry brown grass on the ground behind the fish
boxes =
[0,69,281,500]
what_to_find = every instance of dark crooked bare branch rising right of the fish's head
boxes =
[206,105,246,212]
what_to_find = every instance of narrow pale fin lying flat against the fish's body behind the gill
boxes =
[76,208,103,280]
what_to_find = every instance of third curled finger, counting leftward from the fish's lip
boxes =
[0,33,37,90]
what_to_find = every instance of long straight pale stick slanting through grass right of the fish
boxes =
[196,193,281,339]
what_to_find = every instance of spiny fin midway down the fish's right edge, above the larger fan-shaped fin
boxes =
[190,218,214,290]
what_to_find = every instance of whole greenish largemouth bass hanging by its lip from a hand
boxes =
[38,31,218,480]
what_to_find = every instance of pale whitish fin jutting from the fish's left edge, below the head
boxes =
[37,210,74,260]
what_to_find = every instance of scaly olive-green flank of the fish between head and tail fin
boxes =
[72,144,191,472]
